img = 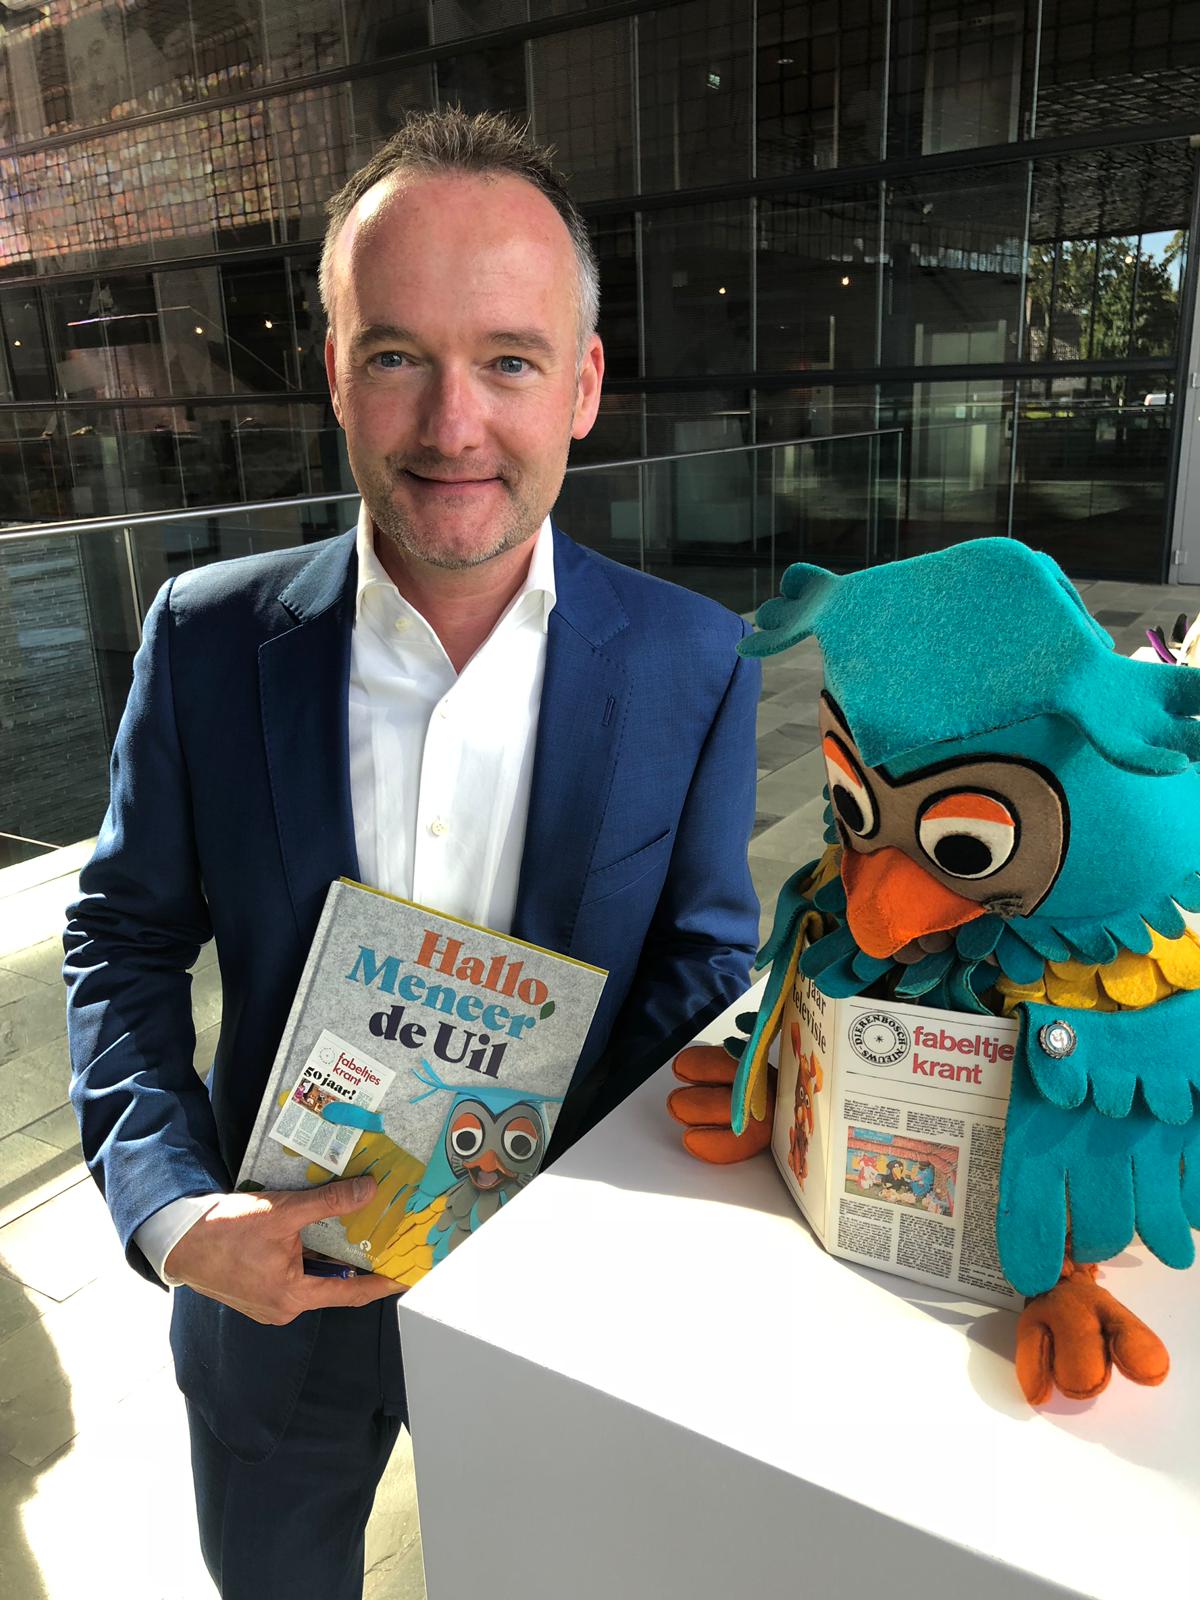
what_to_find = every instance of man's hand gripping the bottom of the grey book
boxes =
[163,1178,403,1326]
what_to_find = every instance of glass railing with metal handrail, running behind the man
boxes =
[0,429,904,864]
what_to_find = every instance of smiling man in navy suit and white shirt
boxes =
[66,112,758,1600]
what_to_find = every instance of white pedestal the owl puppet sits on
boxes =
[400,1003,1200,1600]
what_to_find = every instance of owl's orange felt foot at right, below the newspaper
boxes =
[1016,1264,1170,1405]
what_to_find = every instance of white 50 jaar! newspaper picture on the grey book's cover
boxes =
[270,1029,395,1178]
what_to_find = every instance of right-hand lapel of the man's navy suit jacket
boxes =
[514,530,629,954]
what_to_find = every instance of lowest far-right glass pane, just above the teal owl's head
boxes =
[1013,373,1173,582]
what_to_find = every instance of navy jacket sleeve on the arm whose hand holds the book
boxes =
[64,584,230,1282]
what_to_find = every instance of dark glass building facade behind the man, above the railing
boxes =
[0,0,1200,578]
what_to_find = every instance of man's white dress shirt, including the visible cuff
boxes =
[134,506,555,1285]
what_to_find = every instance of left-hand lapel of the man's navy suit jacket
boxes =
[259,531,358,938]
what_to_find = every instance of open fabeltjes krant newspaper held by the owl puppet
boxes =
[771,976,1022,1309]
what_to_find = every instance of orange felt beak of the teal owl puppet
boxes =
[842,845,984,958]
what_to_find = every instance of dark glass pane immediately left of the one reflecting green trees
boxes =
[882,163,1027,366]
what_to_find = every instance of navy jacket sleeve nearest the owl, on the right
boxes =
[573,640,762,1136]
